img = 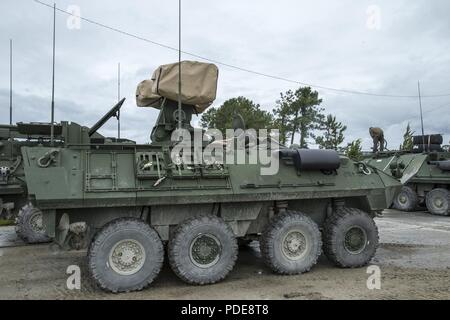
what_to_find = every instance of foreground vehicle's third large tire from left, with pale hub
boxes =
[260,211,322,274]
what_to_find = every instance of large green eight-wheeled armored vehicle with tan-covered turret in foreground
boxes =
[17,62,401,292]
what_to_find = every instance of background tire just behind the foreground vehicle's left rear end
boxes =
[16,204,50,244]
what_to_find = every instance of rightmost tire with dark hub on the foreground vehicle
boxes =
[323,207,378,268]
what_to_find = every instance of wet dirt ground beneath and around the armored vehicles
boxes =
[0,210,450,300]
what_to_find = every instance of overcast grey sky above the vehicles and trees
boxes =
[0,0,450,149]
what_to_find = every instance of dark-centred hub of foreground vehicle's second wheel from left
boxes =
[190,234,222,268]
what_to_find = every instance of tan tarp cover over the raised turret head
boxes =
[152,61,219,113]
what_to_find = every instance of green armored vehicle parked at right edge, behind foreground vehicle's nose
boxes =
[365,134,450,216]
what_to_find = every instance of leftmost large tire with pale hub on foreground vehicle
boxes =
[88,218,164,292]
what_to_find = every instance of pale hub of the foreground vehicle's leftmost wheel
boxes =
[109,239,145,275]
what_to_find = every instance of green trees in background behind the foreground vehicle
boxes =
[200,87,412,161]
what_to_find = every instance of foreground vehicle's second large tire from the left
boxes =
[168,215,238,285]
